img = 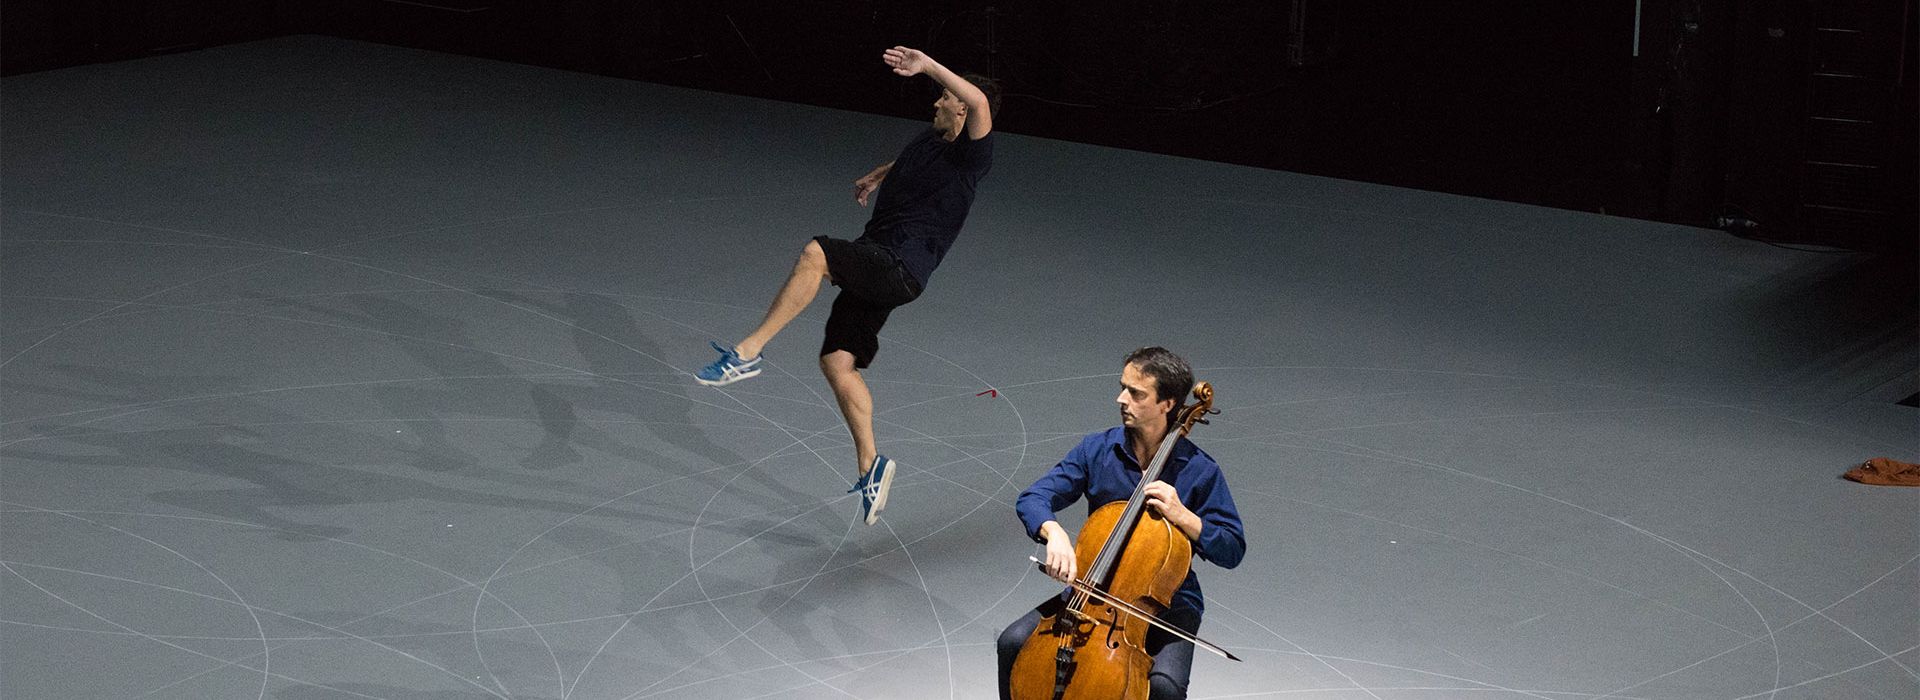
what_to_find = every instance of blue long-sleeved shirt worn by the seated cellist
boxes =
[1014,421,1246,612]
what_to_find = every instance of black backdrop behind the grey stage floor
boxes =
[0,0,1914,247]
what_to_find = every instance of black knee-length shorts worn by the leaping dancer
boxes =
[814,236,920,370]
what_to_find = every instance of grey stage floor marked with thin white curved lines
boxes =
[0,36,1920,700]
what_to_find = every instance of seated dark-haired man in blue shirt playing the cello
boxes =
[998,347,1246,700]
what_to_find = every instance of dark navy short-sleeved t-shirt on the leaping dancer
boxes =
[860,128,993,290]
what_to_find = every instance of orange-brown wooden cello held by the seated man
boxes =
[1008,382,1238,700]
